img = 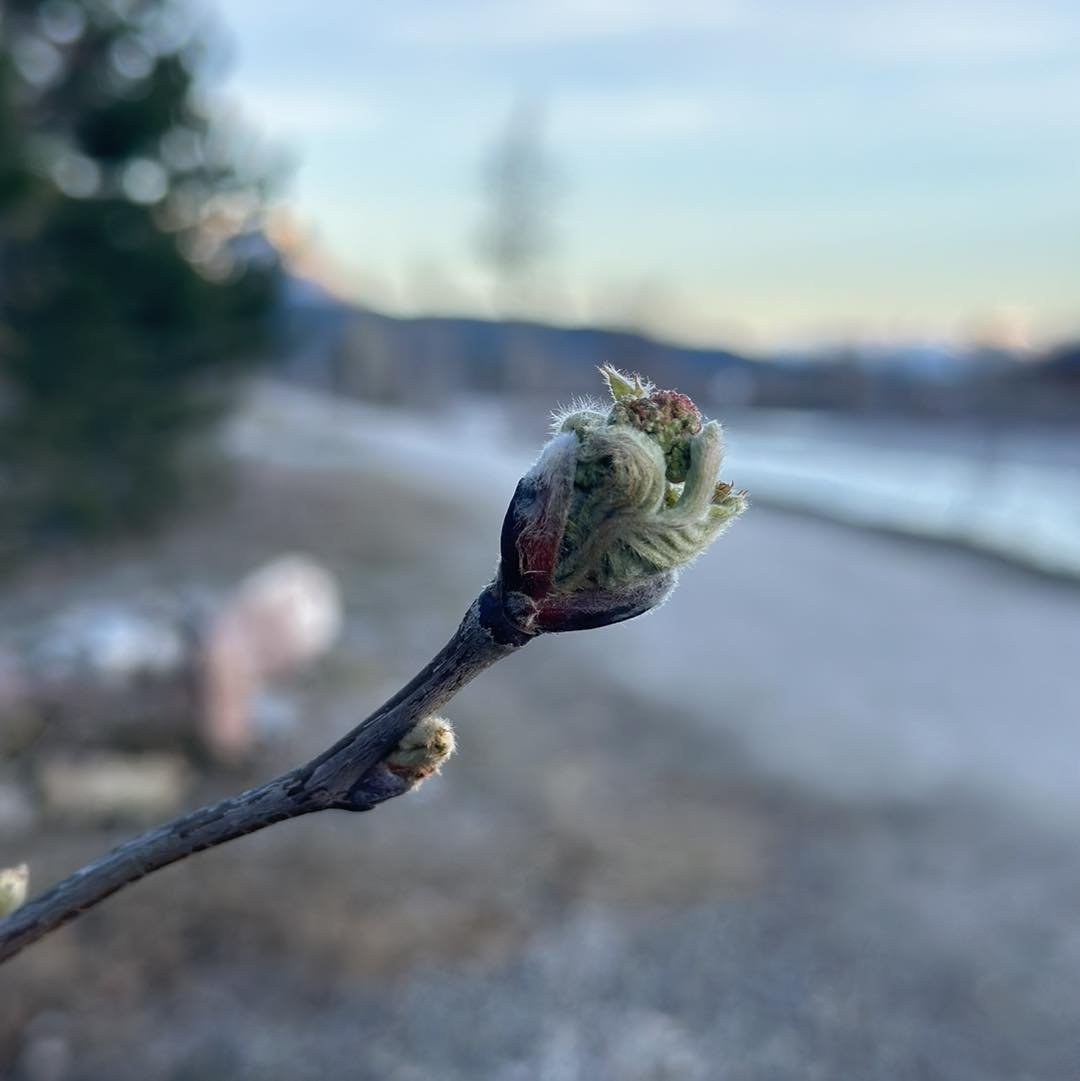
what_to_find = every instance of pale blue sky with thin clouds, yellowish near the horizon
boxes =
[216,0,1080,350]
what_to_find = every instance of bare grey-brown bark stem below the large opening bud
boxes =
[0,586,531,962]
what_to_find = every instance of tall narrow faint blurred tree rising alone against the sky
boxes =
[480,104,556,316]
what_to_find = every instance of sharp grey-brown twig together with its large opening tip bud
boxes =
[0,366,746,961]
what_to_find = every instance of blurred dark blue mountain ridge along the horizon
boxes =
[277,277,1080,419]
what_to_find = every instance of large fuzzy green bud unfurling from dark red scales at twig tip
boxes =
[494,366,746,639]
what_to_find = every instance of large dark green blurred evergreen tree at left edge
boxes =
[0,0,279,558]
